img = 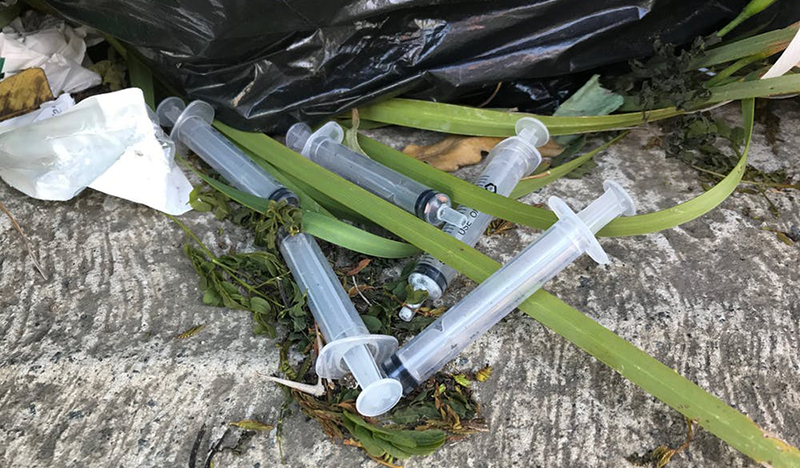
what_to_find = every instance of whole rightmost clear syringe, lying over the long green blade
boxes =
[383,181,636,393]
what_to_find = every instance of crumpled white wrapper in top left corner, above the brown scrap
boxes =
[0,11,103,96]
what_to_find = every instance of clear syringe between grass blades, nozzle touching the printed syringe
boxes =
[286,122,468,227]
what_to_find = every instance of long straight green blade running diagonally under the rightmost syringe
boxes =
[216,101,800,468]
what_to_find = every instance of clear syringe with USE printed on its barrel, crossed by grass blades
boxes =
[399,117,550,322]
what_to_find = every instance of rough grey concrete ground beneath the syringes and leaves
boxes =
[0,99,800,468]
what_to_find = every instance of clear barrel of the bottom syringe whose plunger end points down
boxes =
[279,234,369,343]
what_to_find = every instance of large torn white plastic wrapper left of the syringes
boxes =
[0,88,192,215]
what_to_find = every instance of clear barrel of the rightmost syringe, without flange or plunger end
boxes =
[384,220,584,392]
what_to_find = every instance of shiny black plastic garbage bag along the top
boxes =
[47,0,800,132]
